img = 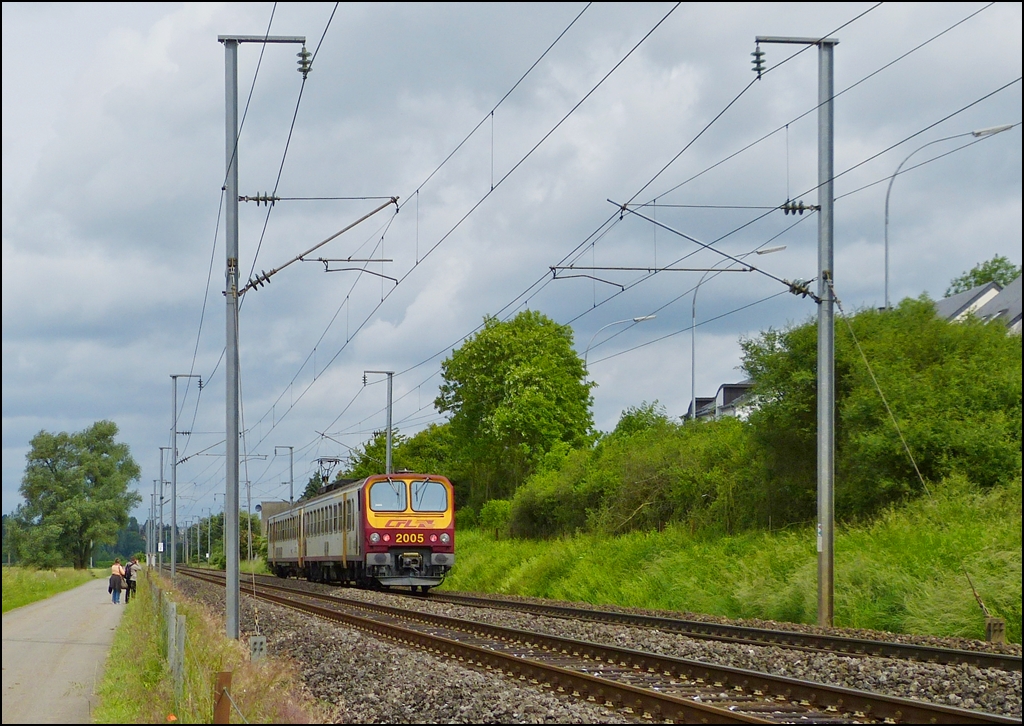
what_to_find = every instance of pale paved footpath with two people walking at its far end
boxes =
[3,578,125,724]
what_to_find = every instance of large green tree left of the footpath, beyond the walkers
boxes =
[11,421,142,568]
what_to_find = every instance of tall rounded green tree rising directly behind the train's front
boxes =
[434,310,593,504]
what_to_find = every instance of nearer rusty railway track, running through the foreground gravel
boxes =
[180,570,1020,724]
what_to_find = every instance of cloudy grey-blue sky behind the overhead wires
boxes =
[3,3,1022,520]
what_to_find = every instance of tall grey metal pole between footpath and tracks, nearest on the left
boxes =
[217,35,308,640]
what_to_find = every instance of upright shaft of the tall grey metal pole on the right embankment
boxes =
[817,39,836,628]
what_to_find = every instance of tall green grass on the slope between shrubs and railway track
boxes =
[444,477,1021,643]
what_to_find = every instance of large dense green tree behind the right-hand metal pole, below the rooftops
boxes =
[742,298,1021,521]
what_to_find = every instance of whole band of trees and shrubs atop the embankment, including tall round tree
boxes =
[335,298,1022,538]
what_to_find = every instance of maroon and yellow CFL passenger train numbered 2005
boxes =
[267,472,455,593]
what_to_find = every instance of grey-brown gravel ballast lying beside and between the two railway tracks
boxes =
[174,578,1022,723]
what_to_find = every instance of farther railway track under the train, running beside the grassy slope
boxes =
[417,593,1021,671]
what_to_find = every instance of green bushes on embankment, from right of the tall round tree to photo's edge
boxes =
[511,300,1021,537]
